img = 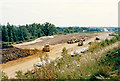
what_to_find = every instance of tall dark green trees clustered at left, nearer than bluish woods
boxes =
[2,22,57,42]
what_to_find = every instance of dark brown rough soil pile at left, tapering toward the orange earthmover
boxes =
[0,47,42,63]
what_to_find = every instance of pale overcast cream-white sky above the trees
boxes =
[0,0,119,27]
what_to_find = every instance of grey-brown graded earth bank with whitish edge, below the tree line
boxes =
[14,33,97,49]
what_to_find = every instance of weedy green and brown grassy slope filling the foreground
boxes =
[1,39,120,81]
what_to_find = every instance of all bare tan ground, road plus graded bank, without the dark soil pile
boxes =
[1,32,116,78]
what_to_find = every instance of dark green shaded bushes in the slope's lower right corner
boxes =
[98,48,120,80]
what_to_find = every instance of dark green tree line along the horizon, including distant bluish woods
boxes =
[0,22,101,43]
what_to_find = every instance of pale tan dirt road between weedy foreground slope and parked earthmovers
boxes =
[1,33,115,78]
